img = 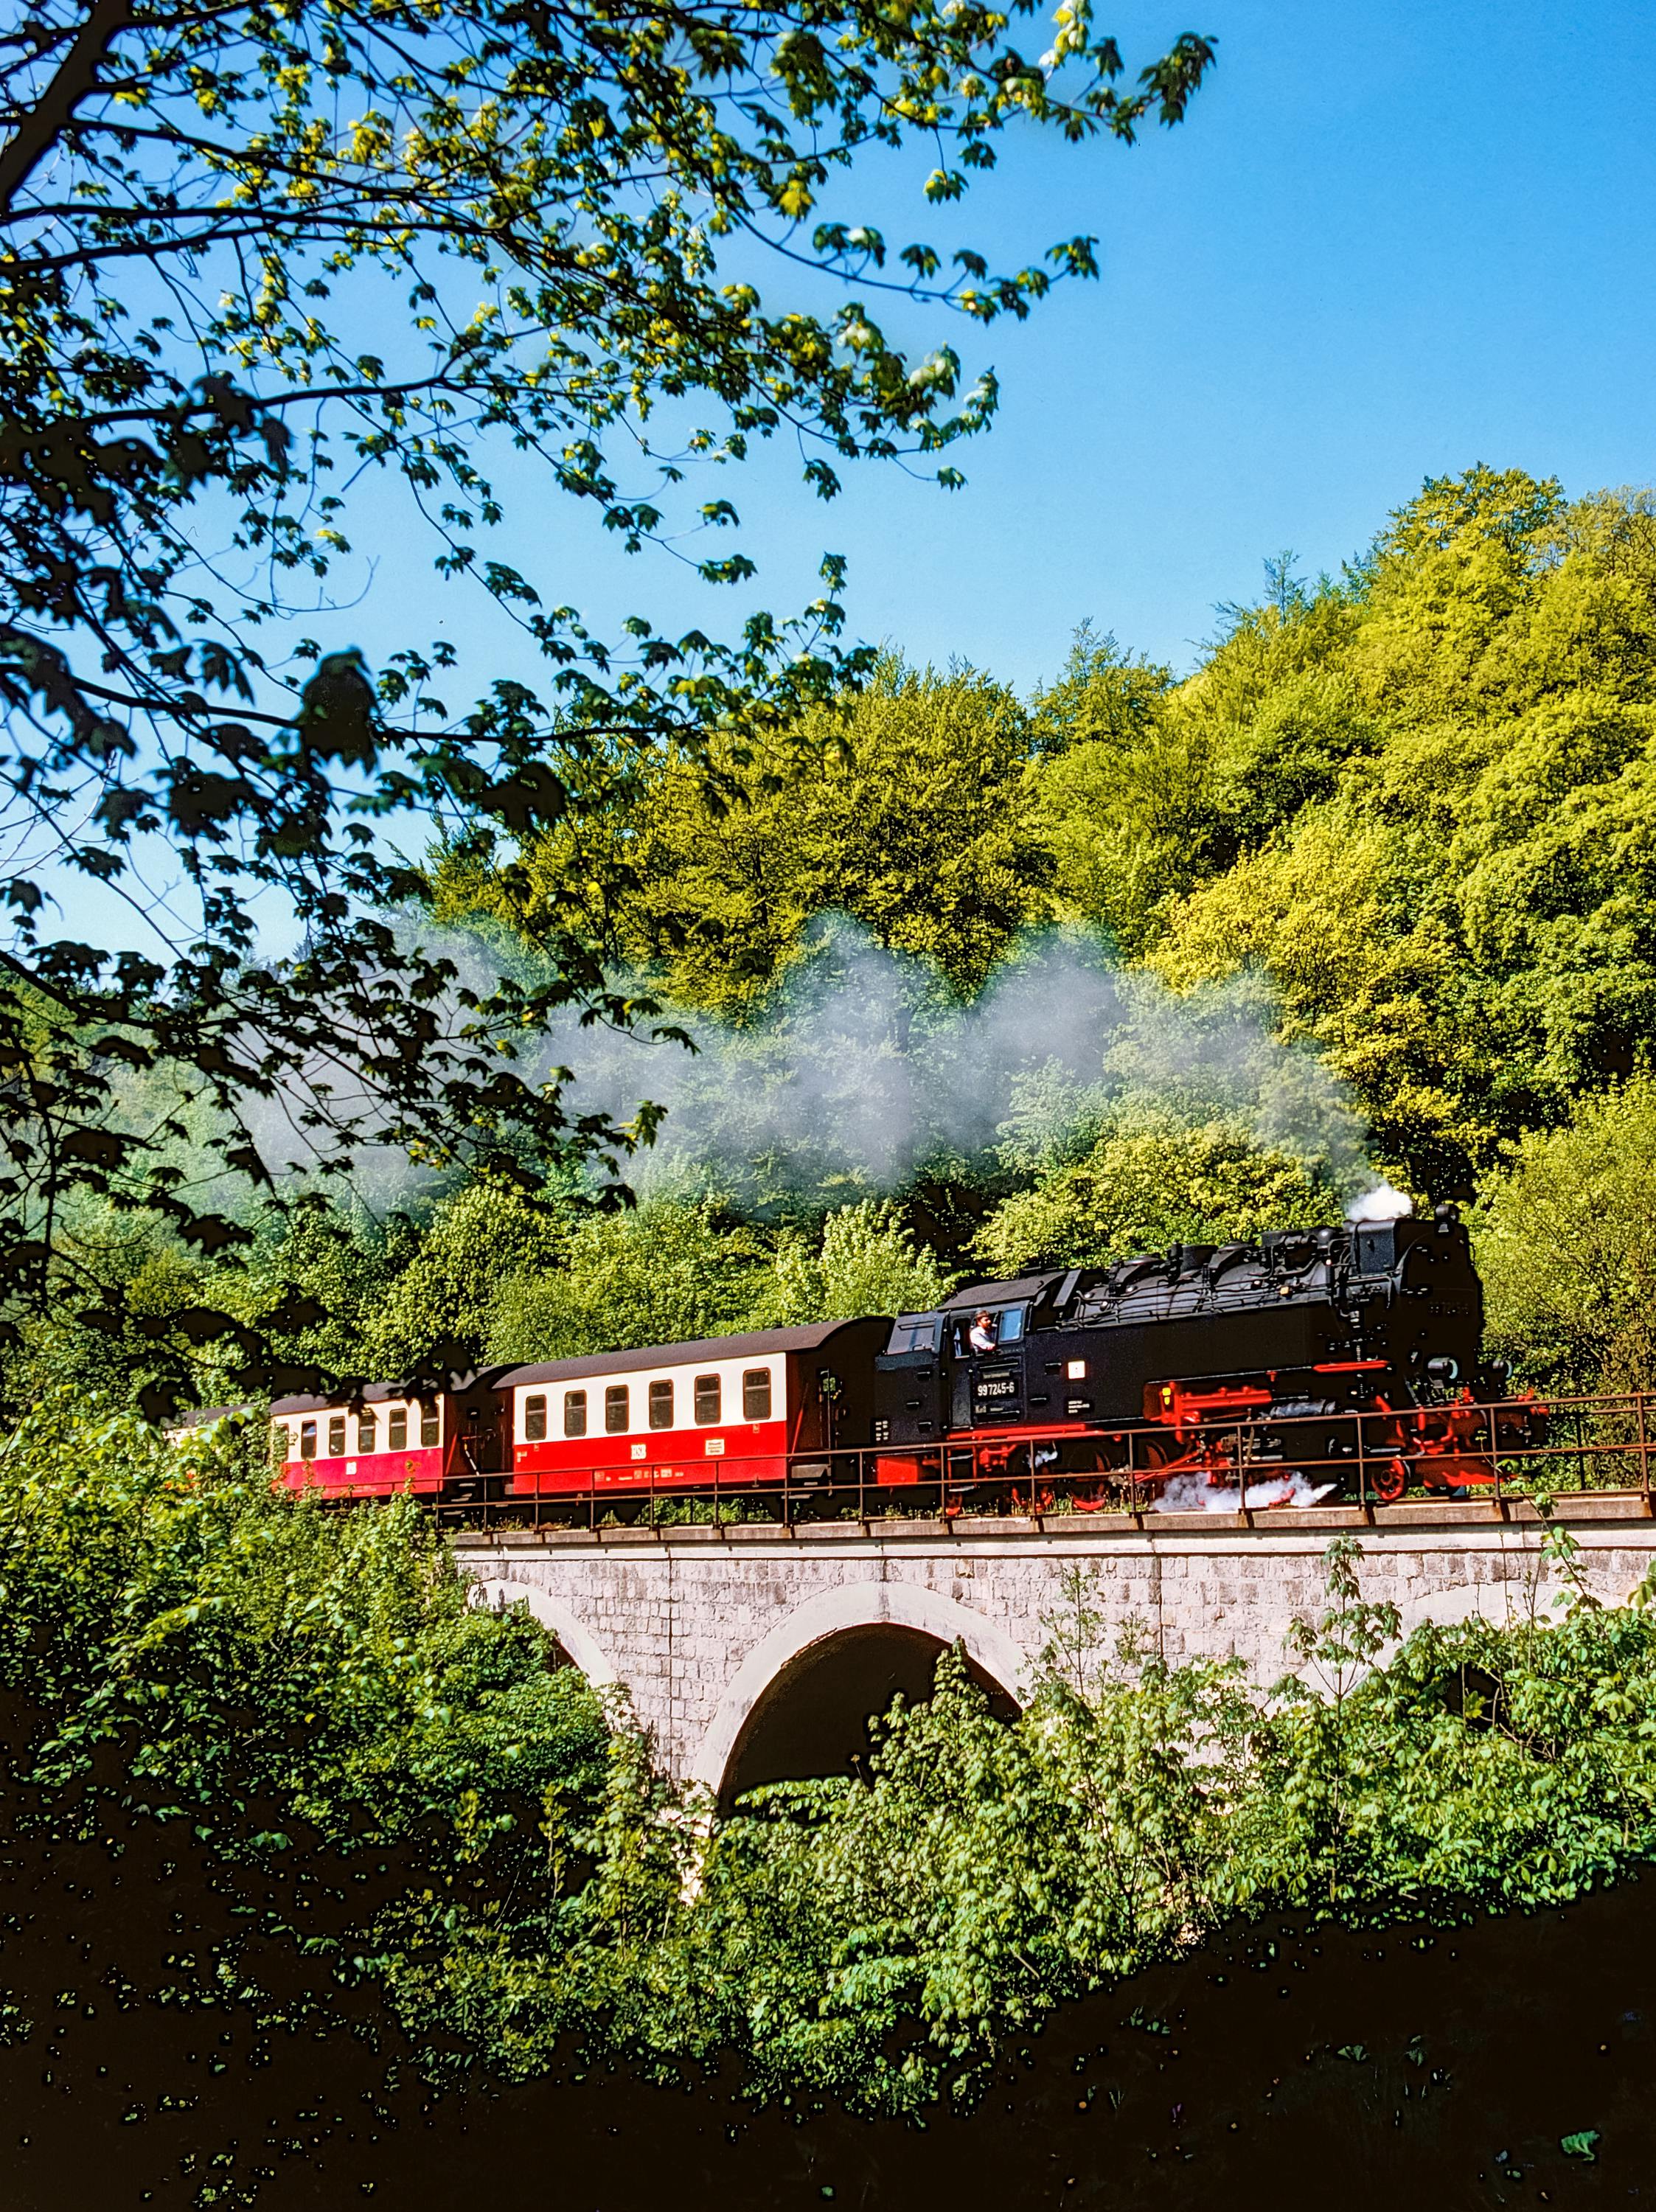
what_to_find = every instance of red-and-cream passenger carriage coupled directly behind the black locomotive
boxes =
[495,1321,891,1498]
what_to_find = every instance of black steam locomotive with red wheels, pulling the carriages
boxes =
[873,1206,1539,1504]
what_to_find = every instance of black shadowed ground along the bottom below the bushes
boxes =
[0,1796,1656,2212]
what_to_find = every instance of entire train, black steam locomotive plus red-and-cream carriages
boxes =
[272,1206,1543,1517]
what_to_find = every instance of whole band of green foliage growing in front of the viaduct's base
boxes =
[13,1407,1656,2110]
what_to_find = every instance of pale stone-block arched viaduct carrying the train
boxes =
[453,1495,1656,1801]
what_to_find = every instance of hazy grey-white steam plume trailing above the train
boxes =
[226,916,1380,1219]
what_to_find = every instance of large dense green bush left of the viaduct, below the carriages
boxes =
[0,1394,608,1955]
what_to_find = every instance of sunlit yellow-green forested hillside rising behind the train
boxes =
[13,467,1656,1398]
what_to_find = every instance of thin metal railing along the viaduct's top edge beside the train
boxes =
[422,1391,1656,1533]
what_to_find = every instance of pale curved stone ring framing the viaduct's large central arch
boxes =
[690,1582,1030,1796]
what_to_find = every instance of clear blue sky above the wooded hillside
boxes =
[331,0,1656,703]
